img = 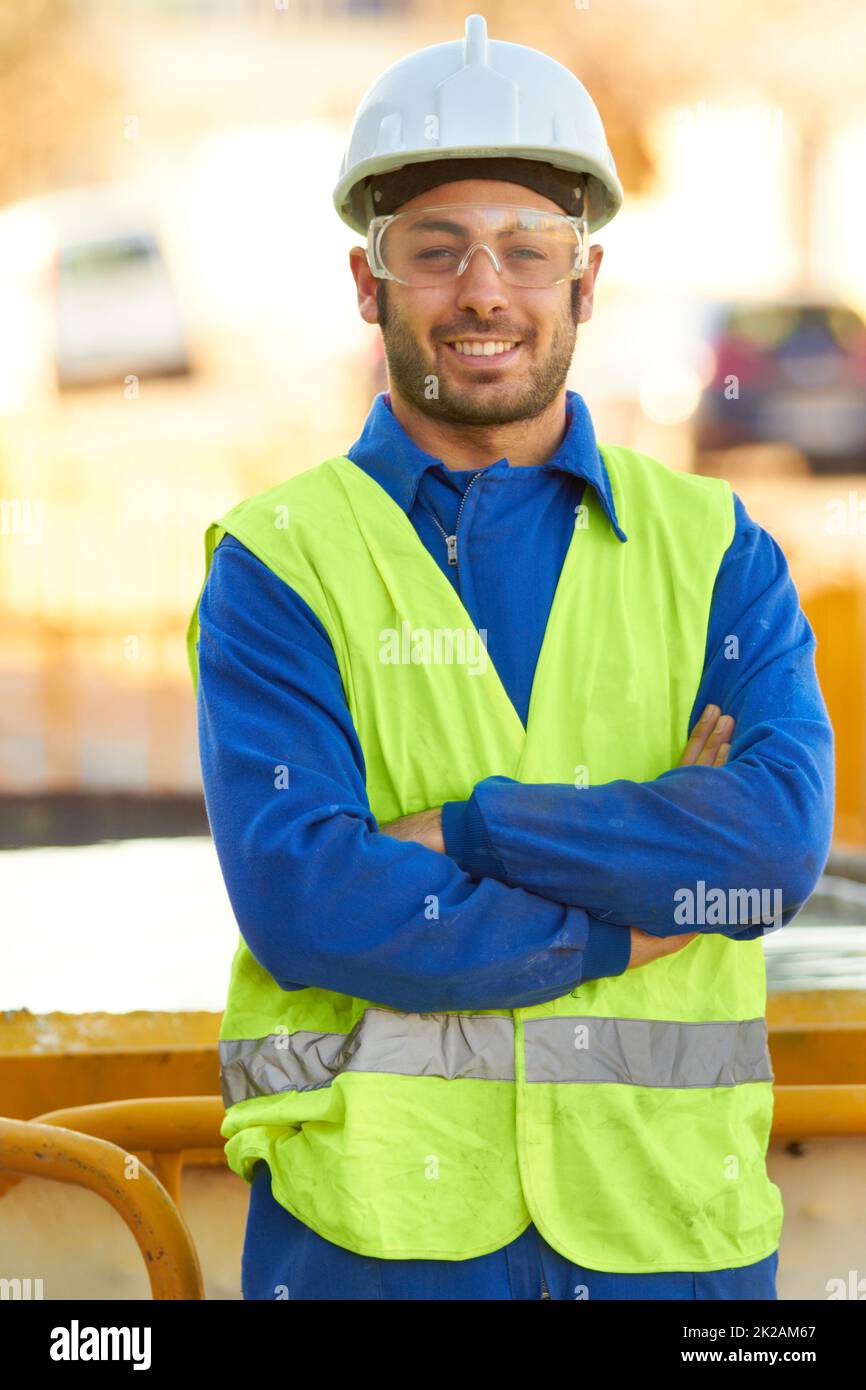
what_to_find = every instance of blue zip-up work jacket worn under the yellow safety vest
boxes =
[197,391,834,1012]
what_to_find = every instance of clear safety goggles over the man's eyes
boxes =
[367,203,589,289]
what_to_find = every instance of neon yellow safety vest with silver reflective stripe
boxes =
[189,445,783,1273]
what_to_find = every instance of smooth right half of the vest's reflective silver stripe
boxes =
[524,1017,773,1090]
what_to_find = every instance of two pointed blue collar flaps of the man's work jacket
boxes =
[346,389,628,541]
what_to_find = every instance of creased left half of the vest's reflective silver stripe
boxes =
[220,1008,514,1105]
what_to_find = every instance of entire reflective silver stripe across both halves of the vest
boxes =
[220,1008,773,1106]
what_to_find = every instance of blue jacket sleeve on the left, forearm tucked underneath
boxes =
[197,537,630,1012]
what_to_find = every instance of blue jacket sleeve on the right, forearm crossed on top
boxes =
[442,495,834,938]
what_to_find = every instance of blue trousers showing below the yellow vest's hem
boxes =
[240,1161,778,1300]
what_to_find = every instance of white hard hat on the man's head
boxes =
[334,14,623,235]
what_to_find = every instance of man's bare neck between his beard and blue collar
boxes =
[391,386,567,470]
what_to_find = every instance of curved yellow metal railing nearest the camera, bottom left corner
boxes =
[0,1118,204,1300]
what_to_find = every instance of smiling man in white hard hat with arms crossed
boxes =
[189,15,833,1300]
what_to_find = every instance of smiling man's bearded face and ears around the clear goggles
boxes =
[353,179,601,425]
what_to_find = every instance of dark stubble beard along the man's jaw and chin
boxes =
[375,279,581,425]
